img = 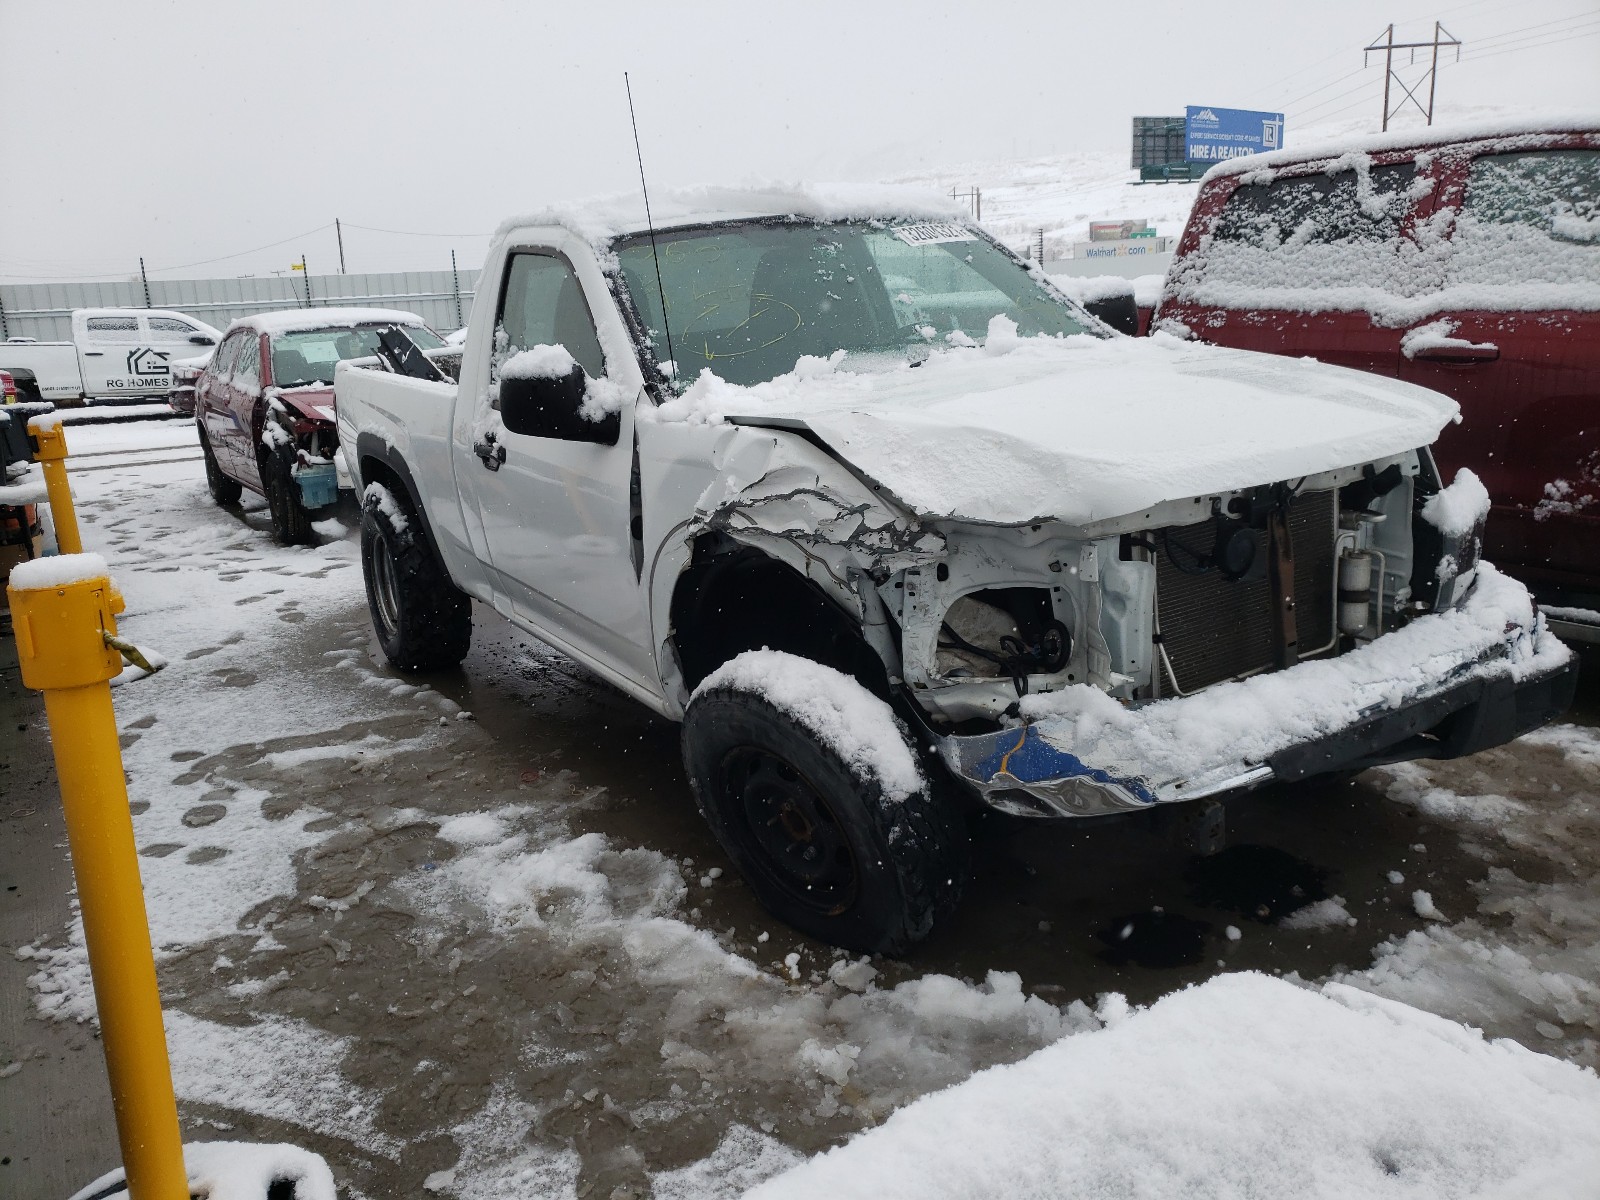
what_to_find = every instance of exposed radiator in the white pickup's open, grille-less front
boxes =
[1155,491,1339,694]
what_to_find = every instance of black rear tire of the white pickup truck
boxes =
[362,483,472,672]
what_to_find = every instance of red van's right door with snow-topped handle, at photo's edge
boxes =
[1400,142,1600,595]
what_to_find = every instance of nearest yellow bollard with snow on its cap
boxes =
[6,563,189,1200]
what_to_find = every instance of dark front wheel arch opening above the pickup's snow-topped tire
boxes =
[672,533,891,699]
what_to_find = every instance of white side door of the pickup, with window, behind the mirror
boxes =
[456,250,658,691]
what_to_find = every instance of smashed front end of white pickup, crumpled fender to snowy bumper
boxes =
[675,432,1576,818]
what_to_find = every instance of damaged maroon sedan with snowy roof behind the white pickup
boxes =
[194,309,445,546]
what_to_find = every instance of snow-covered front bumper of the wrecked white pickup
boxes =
[939,568,1578,818]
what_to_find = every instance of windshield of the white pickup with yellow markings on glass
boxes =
[616,221,1096,389]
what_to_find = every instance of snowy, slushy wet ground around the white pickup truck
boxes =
[9,396,1600,1198]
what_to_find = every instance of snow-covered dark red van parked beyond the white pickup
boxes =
[1154,120,1600,642]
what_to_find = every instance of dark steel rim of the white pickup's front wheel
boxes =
[722,746,861,917]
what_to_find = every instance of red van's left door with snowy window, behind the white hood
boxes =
[1158,162,1427,376]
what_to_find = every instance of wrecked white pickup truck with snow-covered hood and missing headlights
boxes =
[336,189,1576,954]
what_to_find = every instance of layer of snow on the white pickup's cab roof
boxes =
[494,184,968,248]
